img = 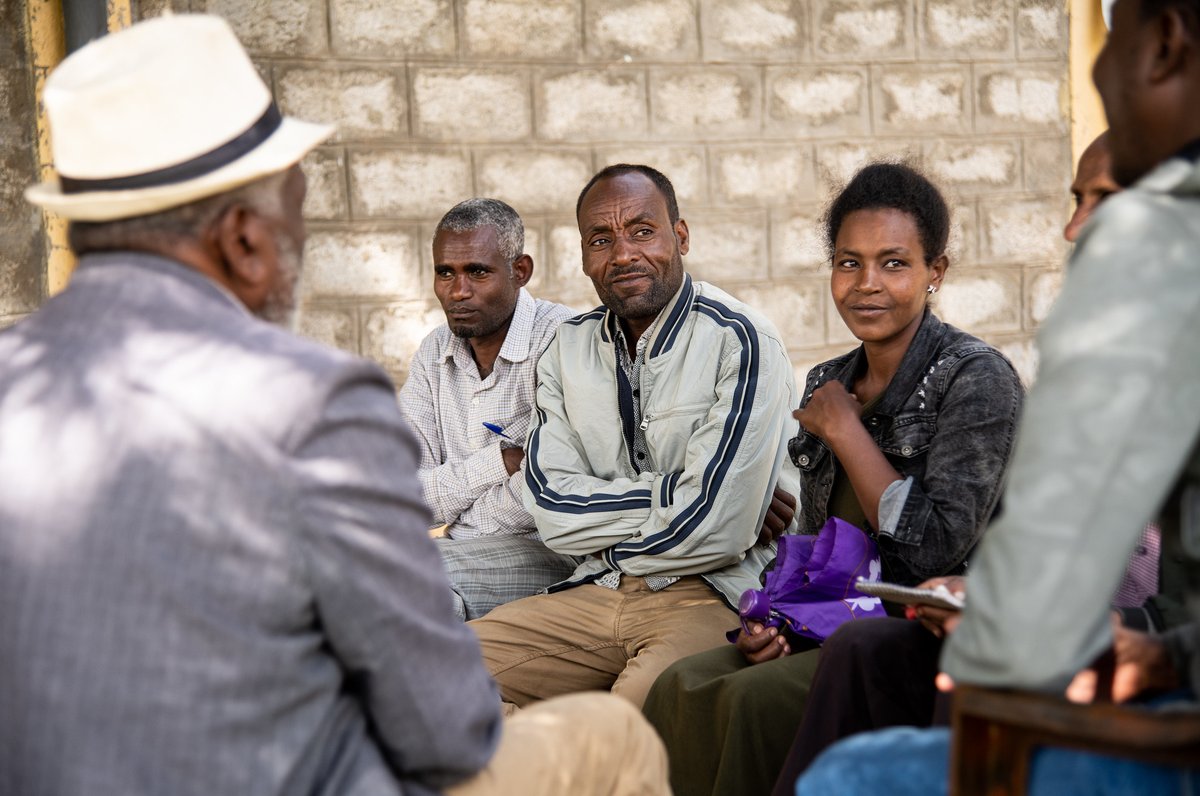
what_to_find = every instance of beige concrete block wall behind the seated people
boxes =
[138,0,1072,379]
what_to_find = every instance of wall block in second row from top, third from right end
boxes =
[767,66,871,136]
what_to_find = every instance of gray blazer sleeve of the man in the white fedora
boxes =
[294,365,500,789]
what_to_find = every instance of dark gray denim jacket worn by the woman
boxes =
[788,310,1024,583]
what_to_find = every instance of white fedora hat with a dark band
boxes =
[25,14,334,221]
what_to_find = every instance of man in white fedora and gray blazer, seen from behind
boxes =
[0,16,667,796]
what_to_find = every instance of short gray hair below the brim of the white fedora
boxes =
[67,170,288,255]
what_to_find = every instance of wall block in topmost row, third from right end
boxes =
[814,0,914,62]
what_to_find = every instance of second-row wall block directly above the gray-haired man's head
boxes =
[413,67,530,142]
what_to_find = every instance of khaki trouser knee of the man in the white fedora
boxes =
[445,694,671,796]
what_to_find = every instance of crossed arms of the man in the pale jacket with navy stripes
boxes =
[526,339,796,575]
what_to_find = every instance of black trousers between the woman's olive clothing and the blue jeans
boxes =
[772,617,942,796]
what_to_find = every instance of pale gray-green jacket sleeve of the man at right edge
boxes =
[942,184,1200,692]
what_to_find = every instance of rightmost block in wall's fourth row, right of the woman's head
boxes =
[980,196,1068,264]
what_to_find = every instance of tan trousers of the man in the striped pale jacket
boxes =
[467,575,738,707]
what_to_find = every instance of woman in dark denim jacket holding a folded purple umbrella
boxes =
[644,163,1022,796]
